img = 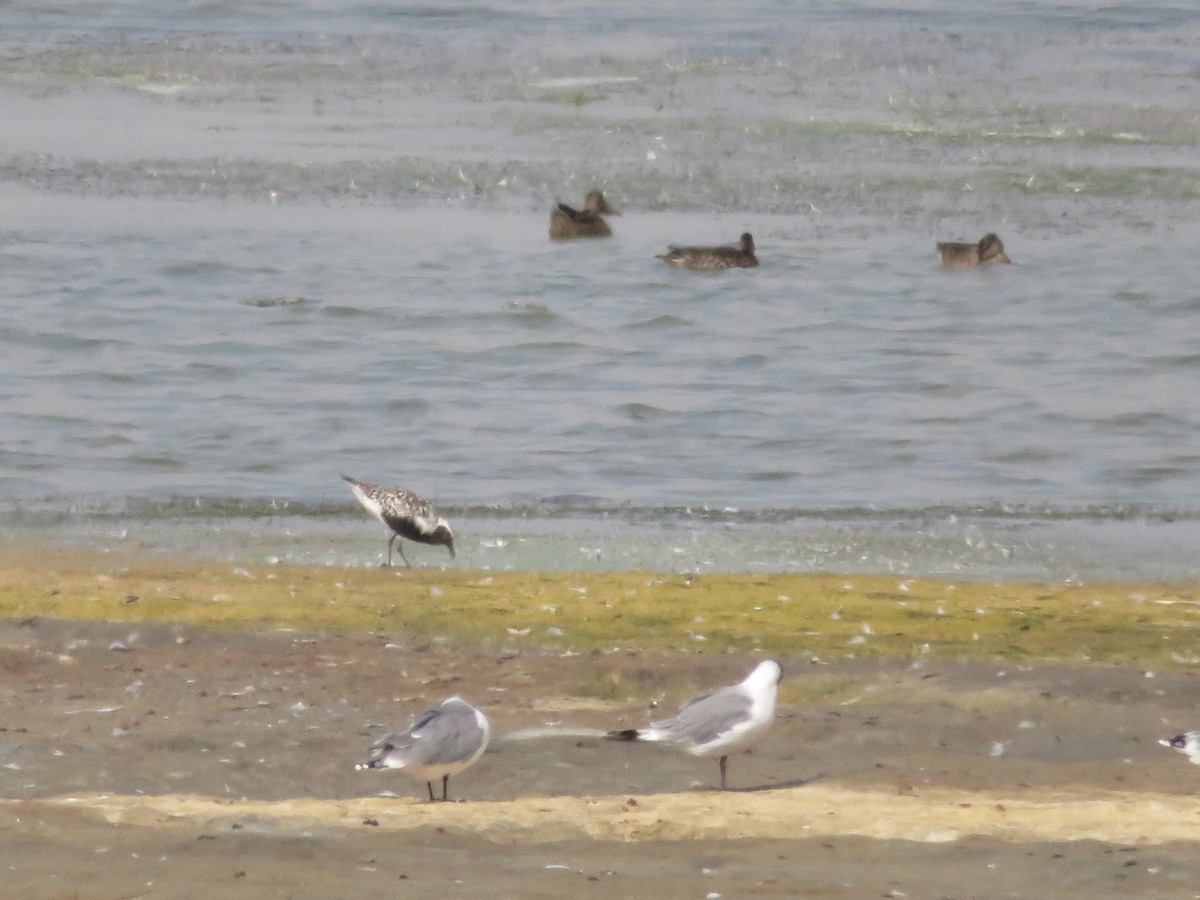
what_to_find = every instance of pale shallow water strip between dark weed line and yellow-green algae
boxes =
[7,502,1200,584]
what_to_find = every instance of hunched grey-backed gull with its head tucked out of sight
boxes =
[354,694,491,802]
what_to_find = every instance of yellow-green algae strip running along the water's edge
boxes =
[0,546,1200,666]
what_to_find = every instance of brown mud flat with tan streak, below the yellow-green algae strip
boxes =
[0,554,1200,898]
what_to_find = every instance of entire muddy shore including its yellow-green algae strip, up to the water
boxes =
[0,545,1200,898]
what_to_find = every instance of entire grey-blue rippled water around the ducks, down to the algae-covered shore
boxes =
[0,2,1200,577]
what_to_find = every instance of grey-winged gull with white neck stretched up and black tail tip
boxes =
[608,659,784,791]
